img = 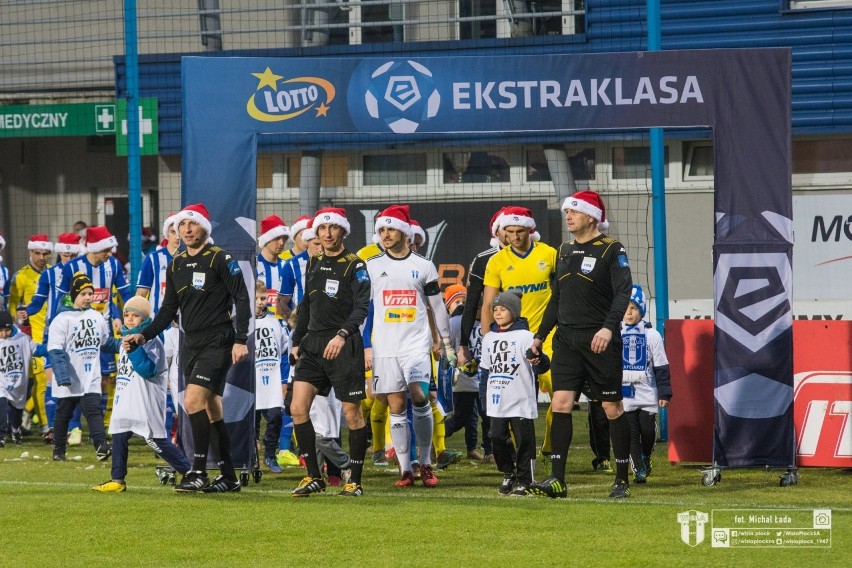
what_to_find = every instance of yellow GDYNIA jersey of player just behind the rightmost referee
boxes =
[483,242,556,332]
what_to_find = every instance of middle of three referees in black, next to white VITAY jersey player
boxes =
[290,207,370,497]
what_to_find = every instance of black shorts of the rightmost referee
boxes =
[550,328,622,402]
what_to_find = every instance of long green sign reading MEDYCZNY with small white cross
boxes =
[0,103,120,138]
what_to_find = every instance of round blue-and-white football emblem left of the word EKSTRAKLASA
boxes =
[364,60,441,134]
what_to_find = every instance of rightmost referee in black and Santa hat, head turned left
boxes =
[532,191,633,498]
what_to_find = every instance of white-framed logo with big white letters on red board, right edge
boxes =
[793,371,852,467]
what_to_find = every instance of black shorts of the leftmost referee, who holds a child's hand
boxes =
[183,325,236,396]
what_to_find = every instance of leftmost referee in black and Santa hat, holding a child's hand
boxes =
[123,203,252,493]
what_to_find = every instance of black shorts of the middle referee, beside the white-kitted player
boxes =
[293,331,367,403]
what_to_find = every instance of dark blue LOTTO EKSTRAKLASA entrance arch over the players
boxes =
[182,48,794,466]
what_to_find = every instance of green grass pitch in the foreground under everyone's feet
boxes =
[0,412,852,568]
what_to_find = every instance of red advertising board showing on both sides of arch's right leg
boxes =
[666,320,852,467]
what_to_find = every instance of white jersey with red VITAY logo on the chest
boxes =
[367,253,438,357]
